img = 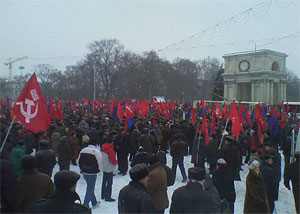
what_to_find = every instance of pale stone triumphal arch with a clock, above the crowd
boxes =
[223,50,287,104]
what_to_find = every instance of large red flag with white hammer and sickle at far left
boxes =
[11,73,51,133]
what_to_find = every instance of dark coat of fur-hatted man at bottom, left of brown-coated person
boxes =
[118,181,155,213]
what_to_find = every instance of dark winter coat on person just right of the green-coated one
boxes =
[35,147,56,177]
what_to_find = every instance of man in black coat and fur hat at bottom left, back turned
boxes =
[31,170,91,213]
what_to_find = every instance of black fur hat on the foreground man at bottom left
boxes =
[54,170,80,190]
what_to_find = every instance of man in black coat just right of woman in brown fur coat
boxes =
[259,154,276,213]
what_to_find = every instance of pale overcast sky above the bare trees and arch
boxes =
[0,0,300,77]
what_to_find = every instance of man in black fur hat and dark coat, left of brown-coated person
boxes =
[118,164,155,213]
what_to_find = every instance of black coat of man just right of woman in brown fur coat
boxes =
[259,161,276,204]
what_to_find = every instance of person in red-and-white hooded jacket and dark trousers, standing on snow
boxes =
[101,138,118,202]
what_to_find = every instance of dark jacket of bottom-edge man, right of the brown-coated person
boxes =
[170,183,221,213]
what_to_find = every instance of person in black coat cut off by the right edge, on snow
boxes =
[284,152,300,213]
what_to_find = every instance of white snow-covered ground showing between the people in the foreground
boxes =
[52,151,296,214]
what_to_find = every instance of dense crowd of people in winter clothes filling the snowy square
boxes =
[0,102,300,213]
